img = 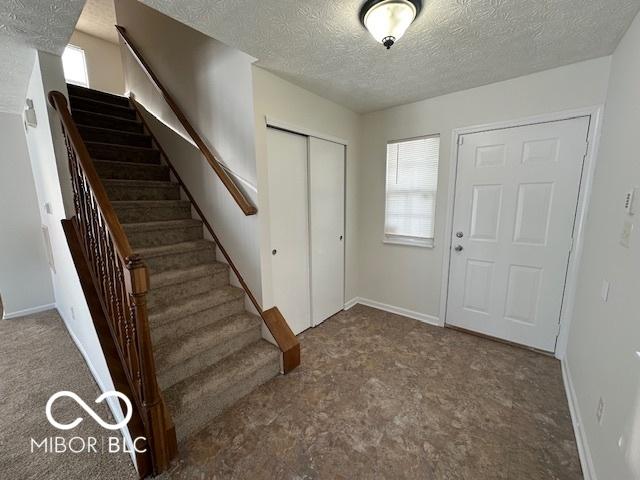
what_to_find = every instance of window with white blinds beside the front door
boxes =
[384,135,440,247]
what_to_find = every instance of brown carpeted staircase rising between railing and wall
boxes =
[68,85,281,442]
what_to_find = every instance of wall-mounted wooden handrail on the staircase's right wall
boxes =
[116,25,258,215]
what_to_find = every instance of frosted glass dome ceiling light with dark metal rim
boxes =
[360,0,422,50]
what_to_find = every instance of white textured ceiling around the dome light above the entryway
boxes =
[141,0,640,112]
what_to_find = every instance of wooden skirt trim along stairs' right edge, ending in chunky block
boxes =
[130,98,300,373]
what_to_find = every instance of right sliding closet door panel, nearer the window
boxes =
[309,137,345,326]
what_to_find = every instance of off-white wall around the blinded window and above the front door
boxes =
[356,57,610,323]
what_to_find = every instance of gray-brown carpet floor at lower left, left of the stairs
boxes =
[0,310,138,480]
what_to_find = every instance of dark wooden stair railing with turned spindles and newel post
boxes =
[49,91,176,474]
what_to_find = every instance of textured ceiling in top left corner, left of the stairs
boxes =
[0,0,84,113]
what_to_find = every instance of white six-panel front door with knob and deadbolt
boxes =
[446,117,589,352]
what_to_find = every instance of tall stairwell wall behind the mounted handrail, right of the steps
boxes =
[116,0,261,301]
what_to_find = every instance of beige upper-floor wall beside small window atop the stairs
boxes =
[69,27,125,95]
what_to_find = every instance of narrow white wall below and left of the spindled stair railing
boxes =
[22,52,132,466]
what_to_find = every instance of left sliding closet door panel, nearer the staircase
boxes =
[267,128,311,335]
